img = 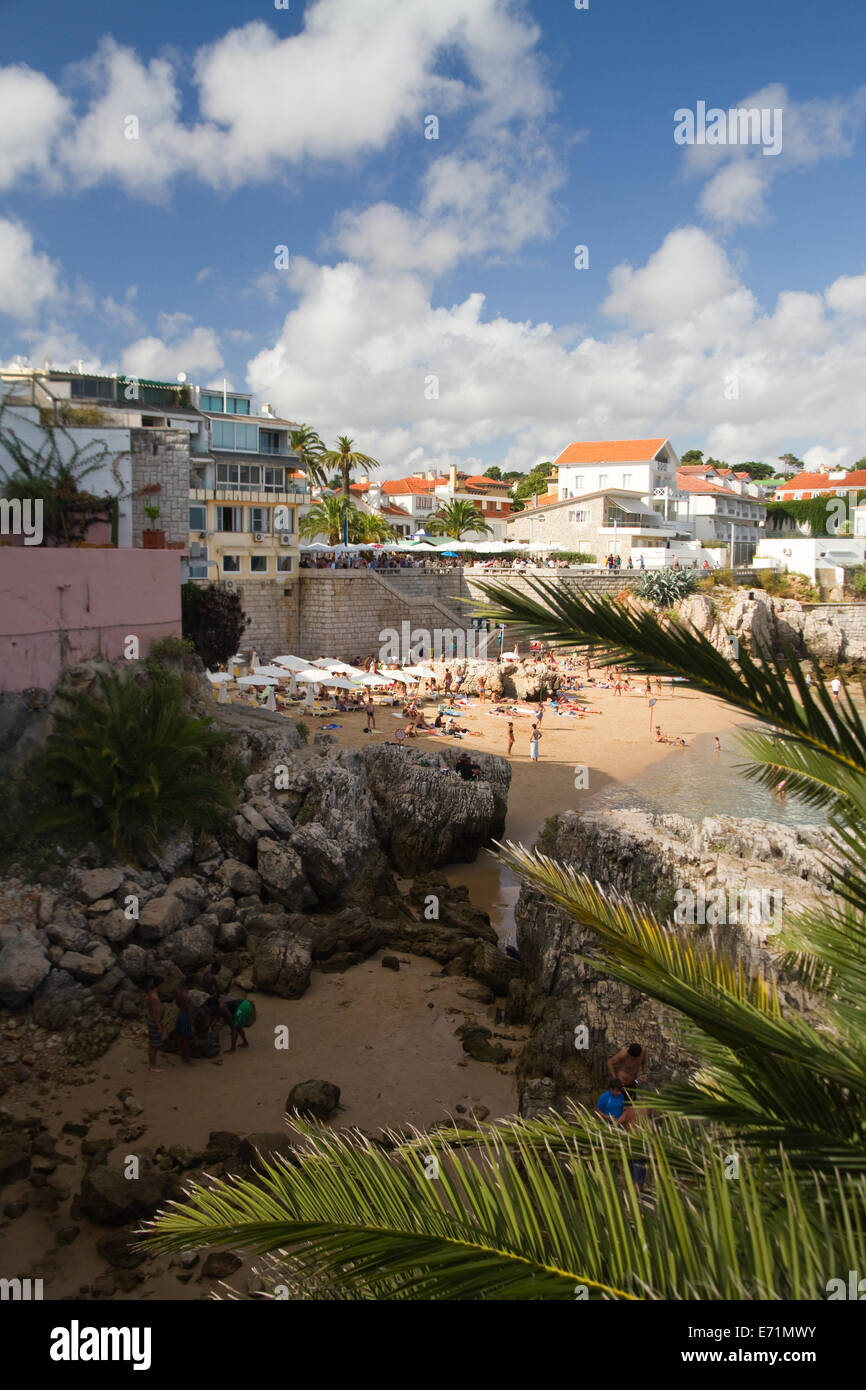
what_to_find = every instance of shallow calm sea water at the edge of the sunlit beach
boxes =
[584,734,824,826]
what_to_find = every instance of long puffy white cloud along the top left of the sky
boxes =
[0,0,550,197]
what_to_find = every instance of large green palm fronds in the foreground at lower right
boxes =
[150,581,866,1301]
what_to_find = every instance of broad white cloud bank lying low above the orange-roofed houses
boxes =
[241,228,866,477]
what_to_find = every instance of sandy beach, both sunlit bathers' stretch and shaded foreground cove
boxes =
[0,667,742,1298]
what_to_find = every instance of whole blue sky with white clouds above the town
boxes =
[0,0,866,475]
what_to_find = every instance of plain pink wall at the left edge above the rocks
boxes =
[0,545,181,691]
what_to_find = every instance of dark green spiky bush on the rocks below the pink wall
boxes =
[35,664,238,858]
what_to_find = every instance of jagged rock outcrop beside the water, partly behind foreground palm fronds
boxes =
[506,810,828,1115]
